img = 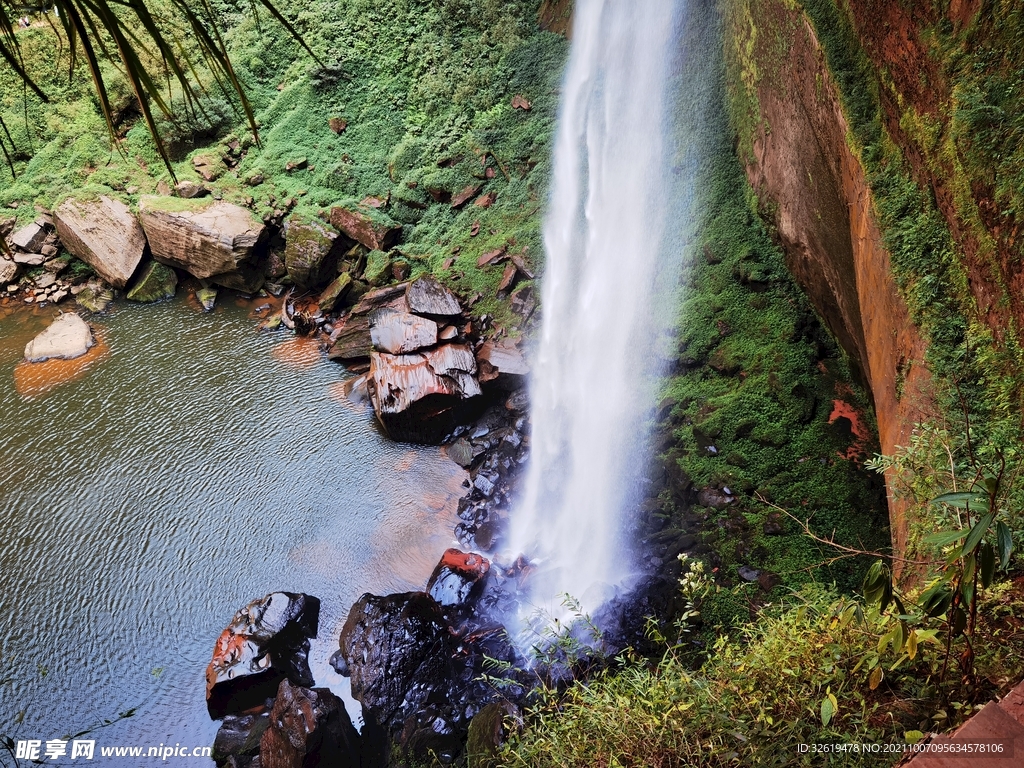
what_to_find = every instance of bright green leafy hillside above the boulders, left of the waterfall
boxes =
[0,0,567,326]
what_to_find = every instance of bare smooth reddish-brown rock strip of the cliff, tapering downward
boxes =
[727,0,931,551]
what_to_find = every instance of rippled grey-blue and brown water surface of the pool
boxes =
[0,300,464,765]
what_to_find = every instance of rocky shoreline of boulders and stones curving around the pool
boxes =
[0,189,695,768]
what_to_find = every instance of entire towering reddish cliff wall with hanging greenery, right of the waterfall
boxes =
[726,0,1024,561]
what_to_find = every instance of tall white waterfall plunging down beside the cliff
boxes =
[510,0,684,610]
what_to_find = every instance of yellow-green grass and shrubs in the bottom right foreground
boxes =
[502,569,1024,768]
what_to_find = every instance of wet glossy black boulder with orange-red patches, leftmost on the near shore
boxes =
[206,592,319,720]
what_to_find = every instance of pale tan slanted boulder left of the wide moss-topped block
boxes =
[53,196,145,288]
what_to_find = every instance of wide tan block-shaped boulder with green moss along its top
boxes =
[138,196,266,293]
